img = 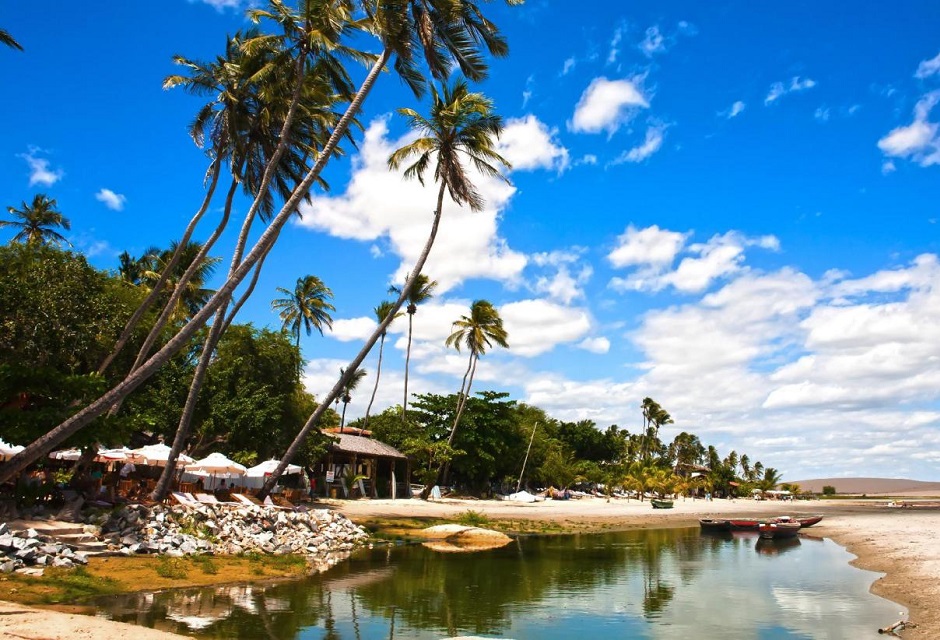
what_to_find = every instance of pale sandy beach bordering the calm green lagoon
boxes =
[0,497,940,640]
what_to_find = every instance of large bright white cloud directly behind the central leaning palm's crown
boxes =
[296,119,524,293]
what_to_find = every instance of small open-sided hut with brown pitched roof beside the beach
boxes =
[313,427,411,498]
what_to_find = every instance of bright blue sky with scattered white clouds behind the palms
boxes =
[0,0,940,480]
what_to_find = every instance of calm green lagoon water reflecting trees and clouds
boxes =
[98,529,902,640]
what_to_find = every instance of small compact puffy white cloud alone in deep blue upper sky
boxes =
[569,77,649,133]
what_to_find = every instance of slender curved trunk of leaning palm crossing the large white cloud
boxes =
[258,139,446,500]
